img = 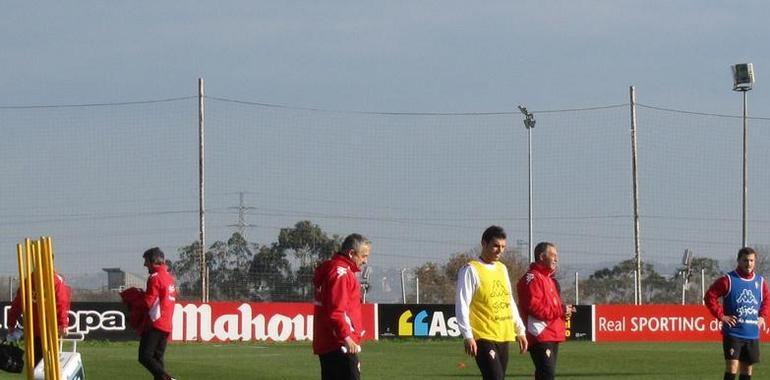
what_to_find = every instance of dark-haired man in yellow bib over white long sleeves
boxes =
[455,226,527,380]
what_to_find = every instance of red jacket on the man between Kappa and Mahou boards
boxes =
[144,264,176,333]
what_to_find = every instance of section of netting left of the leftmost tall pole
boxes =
[0,98,198,294]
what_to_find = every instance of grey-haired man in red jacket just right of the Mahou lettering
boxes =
[313,234,371,380]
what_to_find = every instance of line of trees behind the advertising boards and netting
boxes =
[169,220,770,304]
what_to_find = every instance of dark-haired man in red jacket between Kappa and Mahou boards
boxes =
[139,247,176,380]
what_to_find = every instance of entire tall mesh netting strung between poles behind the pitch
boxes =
[0,97,770,302]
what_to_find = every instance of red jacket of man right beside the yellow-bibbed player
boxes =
[516,262,566,343]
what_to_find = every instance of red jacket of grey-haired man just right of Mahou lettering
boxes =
[313,254,364,355]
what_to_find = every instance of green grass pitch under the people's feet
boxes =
[0,340,770,380]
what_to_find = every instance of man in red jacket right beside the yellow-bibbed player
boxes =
[516,242,574,380]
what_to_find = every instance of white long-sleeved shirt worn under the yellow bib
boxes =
[455,260,525,339]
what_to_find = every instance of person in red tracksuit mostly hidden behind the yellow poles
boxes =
[8,272,70,366]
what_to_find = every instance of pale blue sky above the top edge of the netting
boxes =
[0,0,770,290]
